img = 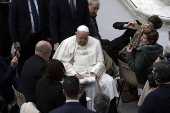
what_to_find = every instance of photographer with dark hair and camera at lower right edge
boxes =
[138,61,170,113]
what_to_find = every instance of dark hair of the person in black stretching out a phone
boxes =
[148,15,162,29]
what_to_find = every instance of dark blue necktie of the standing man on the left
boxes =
[30,0,40,32]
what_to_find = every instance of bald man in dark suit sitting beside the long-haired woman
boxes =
[18,41,52,103]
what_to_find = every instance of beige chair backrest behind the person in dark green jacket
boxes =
[118,59,143,88]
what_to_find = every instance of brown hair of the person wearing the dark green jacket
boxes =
[142,28,159,45]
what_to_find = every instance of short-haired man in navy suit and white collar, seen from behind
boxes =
[49,76,94,113]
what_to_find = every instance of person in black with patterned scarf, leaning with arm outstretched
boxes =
[107,15,162,64]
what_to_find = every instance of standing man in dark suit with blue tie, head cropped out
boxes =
[9,0,49,68]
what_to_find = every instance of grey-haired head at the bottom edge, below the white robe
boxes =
[94,94,110,113]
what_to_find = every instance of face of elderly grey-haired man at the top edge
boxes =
[89,1,100,16]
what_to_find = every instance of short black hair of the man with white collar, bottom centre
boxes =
[63,76,79,98]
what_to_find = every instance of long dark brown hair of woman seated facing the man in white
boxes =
[45,59,65,81]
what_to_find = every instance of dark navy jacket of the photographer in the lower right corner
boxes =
[138,84,170,113]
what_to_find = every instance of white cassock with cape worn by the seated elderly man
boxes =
[53,35,118,109]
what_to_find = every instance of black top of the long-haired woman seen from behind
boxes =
[35,78,66,113]
